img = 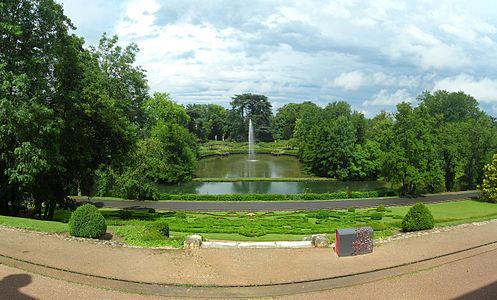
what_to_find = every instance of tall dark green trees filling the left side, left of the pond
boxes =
[0,0,197,219]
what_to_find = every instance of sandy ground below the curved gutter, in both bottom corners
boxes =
[0,251,497,300]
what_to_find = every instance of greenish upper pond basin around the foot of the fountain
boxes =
[195,154,309,178]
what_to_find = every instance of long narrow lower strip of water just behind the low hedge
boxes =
[159,181,386,194]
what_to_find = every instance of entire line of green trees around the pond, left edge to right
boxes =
[0,0,497,219]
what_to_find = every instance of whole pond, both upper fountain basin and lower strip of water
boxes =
[158,154,387,194]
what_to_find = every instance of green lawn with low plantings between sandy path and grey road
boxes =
[0,200,497,247]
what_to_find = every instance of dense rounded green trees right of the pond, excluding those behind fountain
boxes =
[288,91,497,194]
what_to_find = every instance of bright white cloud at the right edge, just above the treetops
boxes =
[433,74,497,102]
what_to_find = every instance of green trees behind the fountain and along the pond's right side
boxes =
[186,91,497,194]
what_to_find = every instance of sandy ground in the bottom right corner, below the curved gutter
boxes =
[282,251,497,300]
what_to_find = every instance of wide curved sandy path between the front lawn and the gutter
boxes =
[0,222,497,285]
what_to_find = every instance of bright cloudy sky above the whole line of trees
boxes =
[59,0,497,117]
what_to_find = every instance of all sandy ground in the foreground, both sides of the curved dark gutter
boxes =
[0,221,497,299]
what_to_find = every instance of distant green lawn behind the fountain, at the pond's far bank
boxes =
[200,140,297,156]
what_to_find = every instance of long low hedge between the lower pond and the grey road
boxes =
[159,191,395,201]
